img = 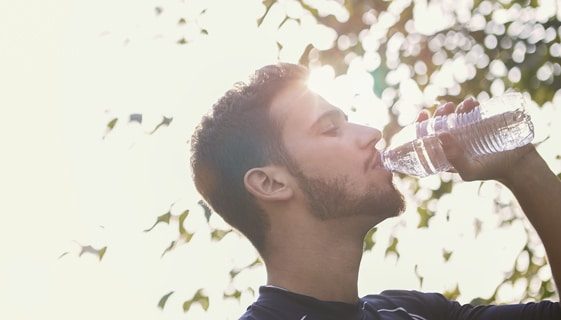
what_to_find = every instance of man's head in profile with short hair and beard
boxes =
[191,64,403,254]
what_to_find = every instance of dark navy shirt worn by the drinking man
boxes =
[240,286,561,320]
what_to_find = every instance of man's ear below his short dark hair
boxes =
[244,166,293,201]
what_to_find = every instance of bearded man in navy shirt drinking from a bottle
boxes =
[191,64,561,320]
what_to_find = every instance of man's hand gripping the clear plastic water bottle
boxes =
[417,98,539,183]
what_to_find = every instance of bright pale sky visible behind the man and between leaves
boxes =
[0,0,558,320]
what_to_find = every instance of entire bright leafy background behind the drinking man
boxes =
[0,0,561,319]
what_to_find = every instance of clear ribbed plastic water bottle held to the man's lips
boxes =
[382,92,534,177]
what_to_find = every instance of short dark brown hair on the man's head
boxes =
[191,63,308,255]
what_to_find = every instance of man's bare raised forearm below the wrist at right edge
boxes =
[501,151,561,293]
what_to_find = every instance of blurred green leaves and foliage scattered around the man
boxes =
[100,0,561,311]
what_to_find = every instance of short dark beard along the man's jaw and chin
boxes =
[294,170,405,224]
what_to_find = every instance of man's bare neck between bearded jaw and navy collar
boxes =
[265,216,365,303]
